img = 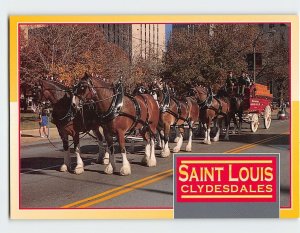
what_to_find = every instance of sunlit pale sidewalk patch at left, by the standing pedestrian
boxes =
[20,128,60,144]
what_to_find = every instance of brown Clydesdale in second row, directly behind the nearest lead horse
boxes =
[151,81,199,157]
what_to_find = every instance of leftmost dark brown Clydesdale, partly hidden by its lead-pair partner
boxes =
[36,80,108,174]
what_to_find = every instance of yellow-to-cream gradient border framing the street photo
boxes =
[9,15,300,219]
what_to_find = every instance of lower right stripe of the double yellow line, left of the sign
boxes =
[77,171,173,208]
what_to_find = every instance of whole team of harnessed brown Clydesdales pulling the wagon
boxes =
[37,73,238,175]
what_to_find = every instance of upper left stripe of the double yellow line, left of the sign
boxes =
[61,169,173,208]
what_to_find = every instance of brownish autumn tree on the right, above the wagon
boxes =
[164,24,278,93]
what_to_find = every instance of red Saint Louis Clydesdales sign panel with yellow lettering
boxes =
[175,155,276,202]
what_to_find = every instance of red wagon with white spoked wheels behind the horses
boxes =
[243,84,273,132]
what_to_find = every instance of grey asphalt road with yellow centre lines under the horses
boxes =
[20,120,290,208]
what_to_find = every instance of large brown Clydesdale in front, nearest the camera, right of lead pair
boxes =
[73,74,159,175]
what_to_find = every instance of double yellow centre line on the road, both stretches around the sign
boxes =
[61,133,287,208]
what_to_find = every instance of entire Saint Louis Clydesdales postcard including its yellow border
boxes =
[9,15,299,219]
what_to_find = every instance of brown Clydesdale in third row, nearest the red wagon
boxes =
[193,86,234,144]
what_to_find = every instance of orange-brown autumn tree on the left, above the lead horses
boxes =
[20,24,130,83]
